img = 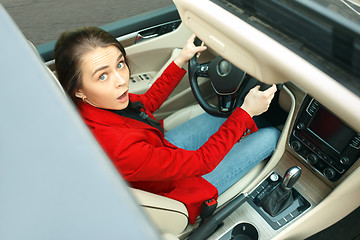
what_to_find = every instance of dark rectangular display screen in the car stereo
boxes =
[308,107,354,153]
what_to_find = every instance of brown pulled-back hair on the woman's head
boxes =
[55,27,128,104]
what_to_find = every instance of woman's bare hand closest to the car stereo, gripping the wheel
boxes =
[241,84,277,117]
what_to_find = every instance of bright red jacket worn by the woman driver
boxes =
[78,63,257,224]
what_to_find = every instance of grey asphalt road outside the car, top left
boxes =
[0,0,173,45]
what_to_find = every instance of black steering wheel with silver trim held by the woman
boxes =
[188,38,271,117]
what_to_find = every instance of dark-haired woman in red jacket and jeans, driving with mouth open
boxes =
[55,27,279,223]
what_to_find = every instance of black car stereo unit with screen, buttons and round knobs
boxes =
[289,96,360,182]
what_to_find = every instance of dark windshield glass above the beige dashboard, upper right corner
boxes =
[212,0,360,96]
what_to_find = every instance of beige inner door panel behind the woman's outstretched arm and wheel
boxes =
[126,24,214,119]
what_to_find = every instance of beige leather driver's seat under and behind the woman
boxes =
[30,43,263,236]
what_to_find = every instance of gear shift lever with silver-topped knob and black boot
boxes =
[254,166,301,217]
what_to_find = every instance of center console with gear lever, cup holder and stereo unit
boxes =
[189,96,360,240]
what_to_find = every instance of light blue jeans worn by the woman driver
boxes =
[165,113,280,195]
